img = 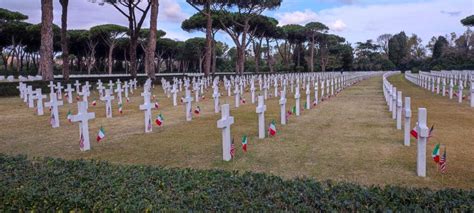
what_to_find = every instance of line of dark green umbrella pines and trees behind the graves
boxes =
[0,3,474,79]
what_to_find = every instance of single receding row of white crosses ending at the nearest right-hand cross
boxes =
[382,71,429,177]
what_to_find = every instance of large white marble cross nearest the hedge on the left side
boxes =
[71,102,95,151]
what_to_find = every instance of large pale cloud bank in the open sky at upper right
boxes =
[275,0,473,43]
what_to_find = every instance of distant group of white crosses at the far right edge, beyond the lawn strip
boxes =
[405,71,474,107]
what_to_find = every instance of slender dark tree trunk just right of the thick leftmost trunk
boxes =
[59,0,69,80]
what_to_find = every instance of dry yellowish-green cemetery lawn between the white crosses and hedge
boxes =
[0,75,474,189]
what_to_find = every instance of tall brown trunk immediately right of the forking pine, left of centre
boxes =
[145,0,159,80]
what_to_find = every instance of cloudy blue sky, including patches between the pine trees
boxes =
[0,0,474,46]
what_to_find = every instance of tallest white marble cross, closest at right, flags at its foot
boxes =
[416,108,429,177]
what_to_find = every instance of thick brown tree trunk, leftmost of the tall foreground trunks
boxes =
[39,0,54,81]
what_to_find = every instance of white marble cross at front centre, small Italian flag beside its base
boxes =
[217,104,234,161]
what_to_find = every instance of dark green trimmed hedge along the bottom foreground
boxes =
[0,154,474,212]
